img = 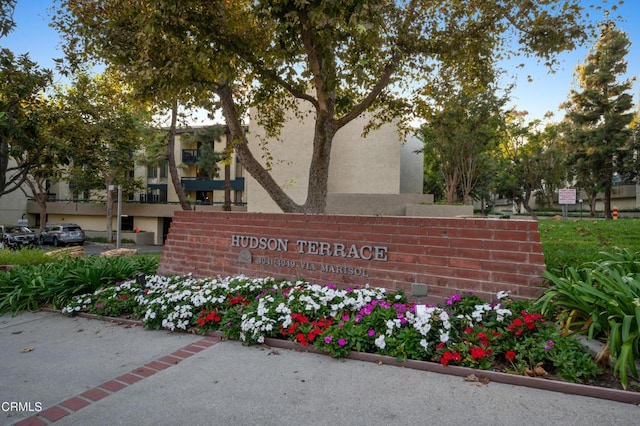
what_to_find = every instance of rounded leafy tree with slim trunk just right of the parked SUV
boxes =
[60,72,152,238]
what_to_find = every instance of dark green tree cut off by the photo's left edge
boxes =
[0,49,52,196]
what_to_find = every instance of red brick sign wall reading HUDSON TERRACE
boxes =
[159,211,545,302]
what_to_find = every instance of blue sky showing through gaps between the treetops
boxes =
[0,0,640,121]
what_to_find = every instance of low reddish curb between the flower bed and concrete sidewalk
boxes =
[47,308,640,405]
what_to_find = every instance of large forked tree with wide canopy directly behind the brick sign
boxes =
[56,0,596,212]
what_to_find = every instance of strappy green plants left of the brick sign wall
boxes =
[0,256,157,314]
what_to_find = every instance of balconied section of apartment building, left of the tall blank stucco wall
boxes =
[17,128,246,244]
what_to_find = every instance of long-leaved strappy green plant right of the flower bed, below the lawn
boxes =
[537,249,640,388]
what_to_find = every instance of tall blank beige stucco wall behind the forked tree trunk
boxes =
[246,105,423,213]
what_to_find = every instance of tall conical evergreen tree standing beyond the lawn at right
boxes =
[565,22,633,219]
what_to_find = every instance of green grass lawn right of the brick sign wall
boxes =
[538,219,640,269]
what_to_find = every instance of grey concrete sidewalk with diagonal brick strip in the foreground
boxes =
[0,312,640,426]
